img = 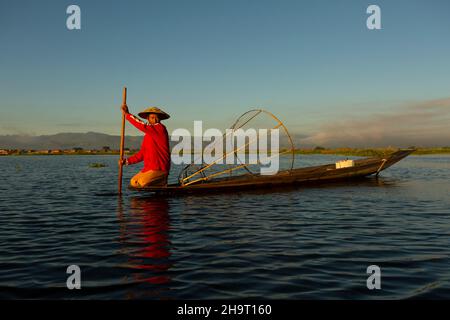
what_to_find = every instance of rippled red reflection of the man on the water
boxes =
[119,197,171,284]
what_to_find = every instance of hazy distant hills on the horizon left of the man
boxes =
[0,132,143,150]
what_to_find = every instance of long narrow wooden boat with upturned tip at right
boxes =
[130,149,415,195]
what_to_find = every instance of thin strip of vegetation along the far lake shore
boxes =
[0,147,450,157]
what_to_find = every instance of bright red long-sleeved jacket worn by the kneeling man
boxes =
[126,113,170,173]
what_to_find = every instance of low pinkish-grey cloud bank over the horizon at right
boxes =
[300,98,450,147]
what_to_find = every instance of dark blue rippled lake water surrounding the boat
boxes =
[0,156,450,299]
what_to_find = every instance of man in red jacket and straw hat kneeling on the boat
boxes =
[119,104,170,188]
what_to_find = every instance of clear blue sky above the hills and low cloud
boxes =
[0,0,450,146]
